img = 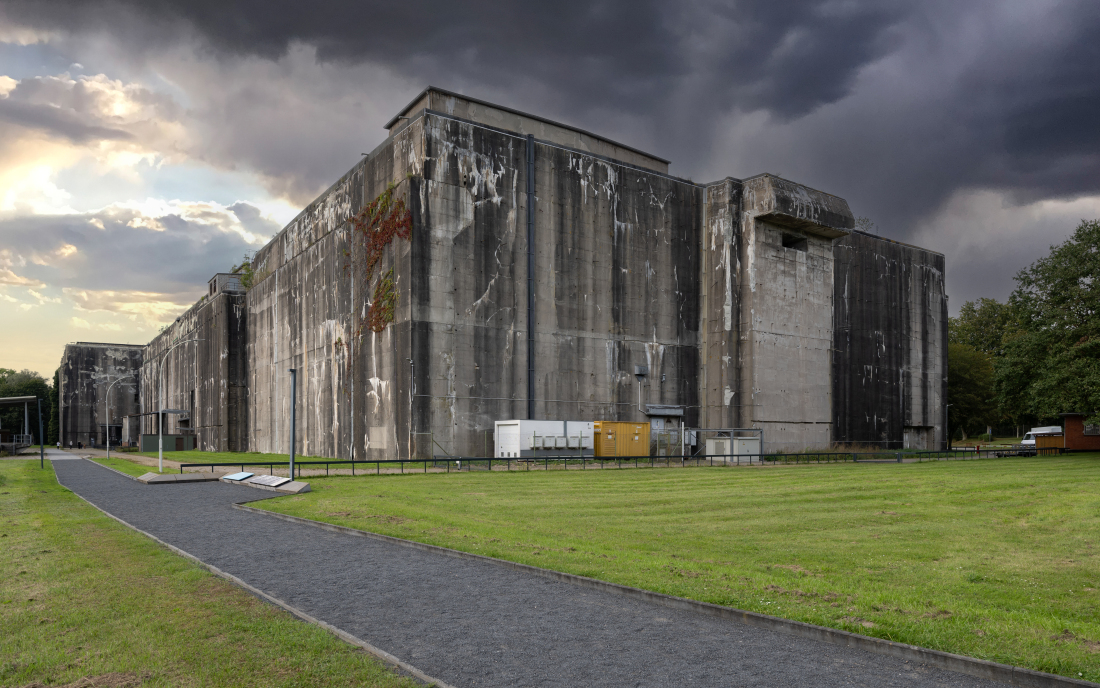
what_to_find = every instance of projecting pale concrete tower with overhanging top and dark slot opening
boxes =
[699,175,854,450]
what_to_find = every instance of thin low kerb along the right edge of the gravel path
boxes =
[236,499,1100,688]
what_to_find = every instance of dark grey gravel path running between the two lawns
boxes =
[54,461,1004,688]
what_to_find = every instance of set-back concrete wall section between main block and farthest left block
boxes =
[141,292,249,451]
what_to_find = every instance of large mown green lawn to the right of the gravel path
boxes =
[251,455,1100,680]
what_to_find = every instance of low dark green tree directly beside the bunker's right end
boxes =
[947,342,998,439]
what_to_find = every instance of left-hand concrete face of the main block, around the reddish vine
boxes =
[248,121,427,459]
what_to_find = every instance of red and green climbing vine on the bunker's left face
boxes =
[340,175,413,346]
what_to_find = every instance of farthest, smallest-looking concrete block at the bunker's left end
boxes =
[59,341,144,447]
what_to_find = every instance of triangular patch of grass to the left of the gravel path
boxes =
[0,459,415,687]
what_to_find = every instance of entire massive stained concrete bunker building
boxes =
[61,88,947,460]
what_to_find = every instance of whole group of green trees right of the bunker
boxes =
[947,220,1100,438]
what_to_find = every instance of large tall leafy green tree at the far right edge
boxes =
[997,220,1100,423]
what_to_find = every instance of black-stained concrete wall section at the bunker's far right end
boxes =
[833,231,947,449]
